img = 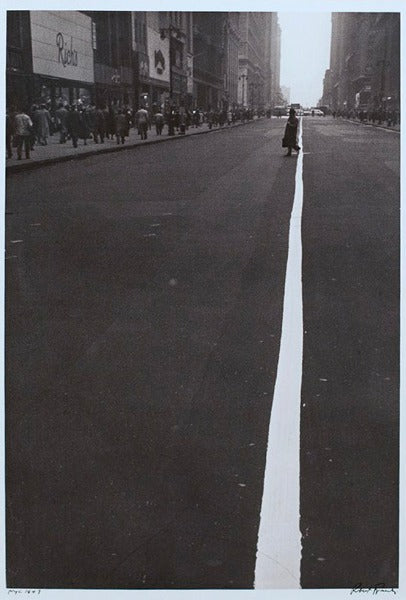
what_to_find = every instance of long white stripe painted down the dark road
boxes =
[254,120,303,589]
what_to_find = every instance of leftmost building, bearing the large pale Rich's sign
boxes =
[6,11,95,109]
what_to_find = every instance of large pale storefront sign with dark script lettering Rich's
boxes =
[30,11,94,83]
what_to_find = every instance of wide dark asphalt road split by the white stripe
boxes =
[6,118,400,589]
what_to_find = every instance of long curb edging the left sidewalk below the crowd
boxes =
[6,117,263,177]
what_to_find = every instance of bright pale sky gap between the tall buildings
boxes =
[278,12,331,107]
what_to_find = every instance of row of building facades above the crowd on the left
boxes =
[6,11,280,116]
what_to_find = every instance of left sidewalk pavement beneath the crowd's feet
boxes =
[5,119,257,174]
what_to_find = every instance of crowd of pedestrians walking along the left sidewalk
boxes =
[6,102,264,160]
